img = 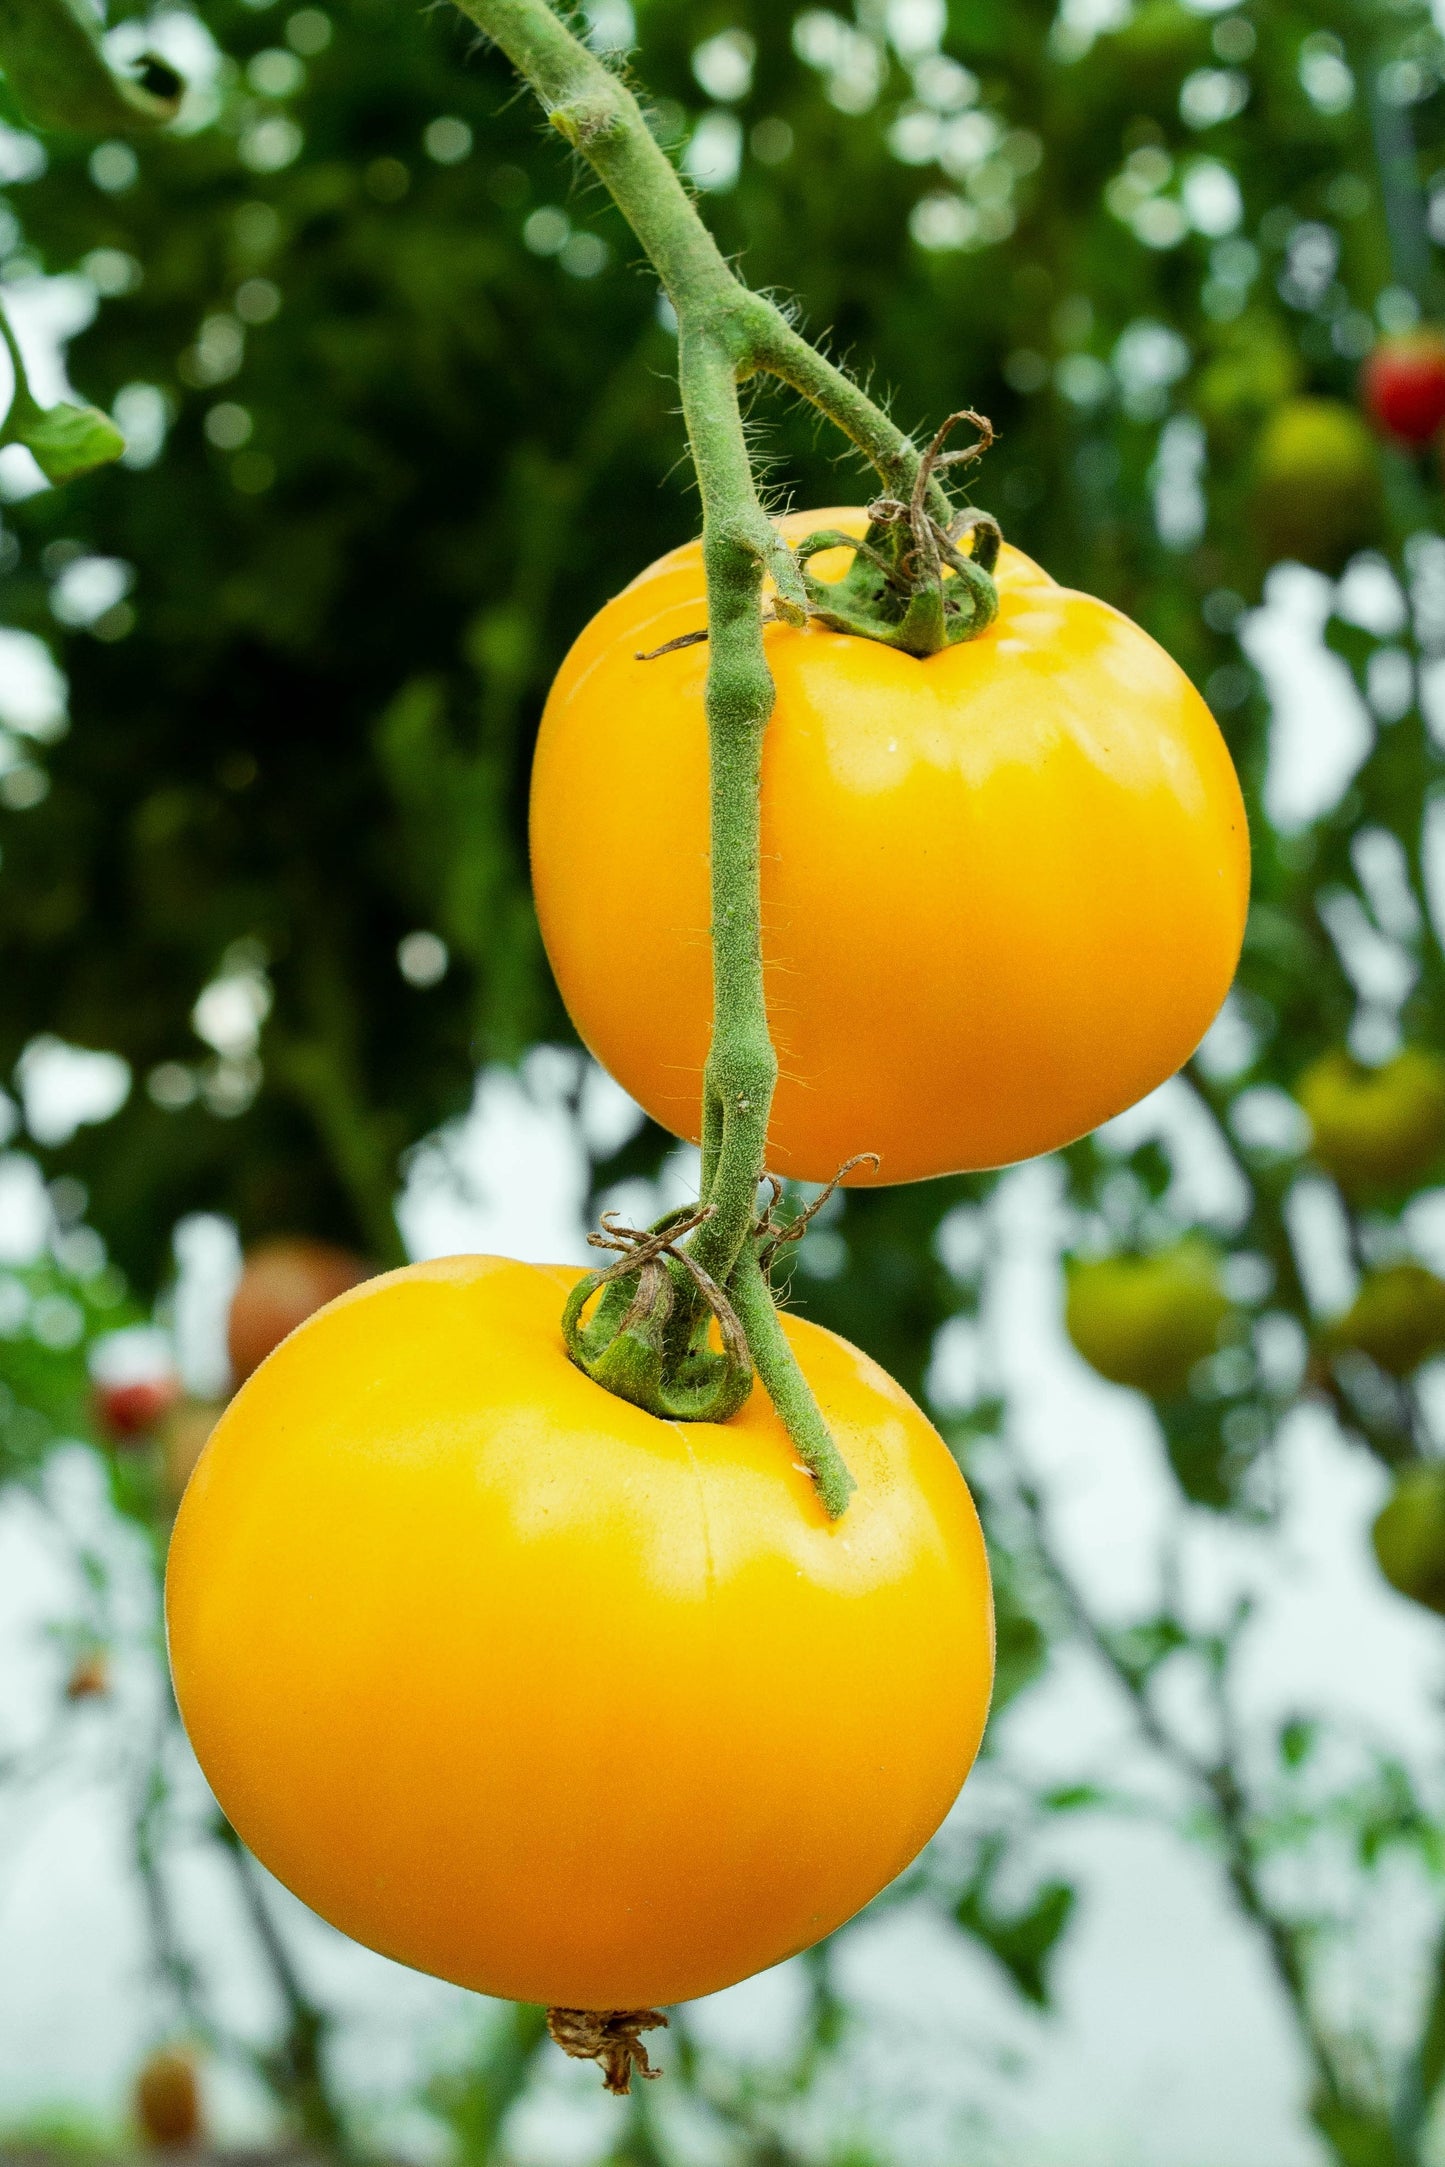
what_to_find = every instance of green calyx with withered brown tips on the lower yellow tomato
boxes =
[561,1205,752,1422]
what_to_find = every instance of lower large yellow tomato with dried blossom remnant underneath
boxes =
[167,1257,992,2009]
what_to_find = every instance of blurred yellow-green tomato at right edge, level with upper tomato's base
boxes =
[1298,1047,1445,1192]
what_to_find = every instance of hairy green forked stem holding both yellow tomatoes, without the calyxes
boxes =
[457,0,970,1517]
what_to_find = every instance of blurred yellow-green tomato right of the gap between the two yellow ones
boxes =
[1064,1235,1231,1400]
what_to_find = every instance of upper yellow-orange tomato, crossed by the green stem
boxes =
[531,511,1250,1181]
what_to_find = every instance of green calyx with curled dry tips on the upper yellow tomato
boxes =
[797,407,1003,657]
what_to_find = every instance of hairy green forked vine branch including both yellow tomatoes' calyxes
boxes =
[457,0,999,1519]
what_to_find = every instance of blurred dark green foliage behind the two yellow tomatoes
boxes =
[0,0,1445,2167]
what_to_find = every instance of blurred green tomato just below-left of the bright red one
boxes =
[1254,399,1382,572]
